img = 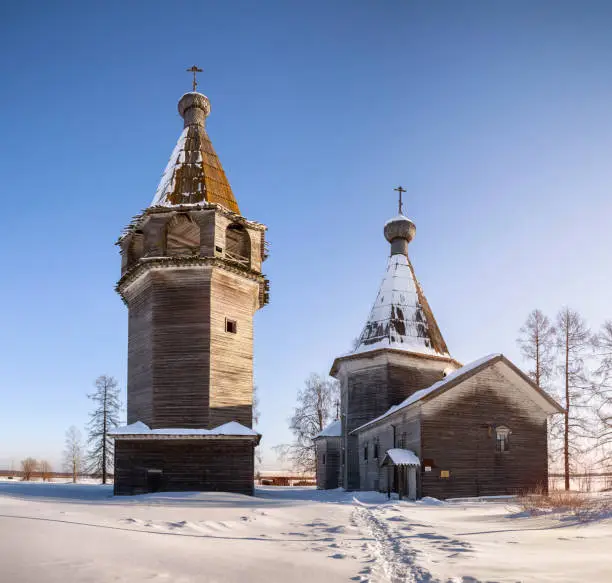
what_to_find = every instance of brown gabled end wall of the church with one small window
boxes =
[421,363,548,499]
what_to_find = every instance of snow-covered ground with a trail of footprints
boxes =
[0,481,612,583]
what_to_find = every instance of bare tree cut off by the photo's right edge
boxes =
[593,320,612,460]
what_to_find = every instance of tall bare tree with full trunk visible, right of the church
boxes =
[556,308,591,490]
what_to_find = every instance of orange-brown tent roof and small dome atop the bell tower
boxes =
[151,93,240,214]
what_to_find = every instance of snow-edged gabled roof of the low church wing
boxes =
[351,354,564,433]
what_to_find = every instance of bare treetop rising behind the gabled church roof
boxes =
[517,309,555,388]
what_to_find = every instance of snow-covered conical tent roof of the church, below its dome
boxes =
[352,253,449,357]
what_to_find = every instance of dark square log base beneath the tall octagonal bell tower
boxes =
[114,438,255,495]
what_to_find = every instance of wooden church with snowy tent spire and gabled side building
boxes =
[315,204,563,499]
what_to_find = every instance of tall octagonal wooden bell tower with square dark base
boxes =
[113,67,268,494]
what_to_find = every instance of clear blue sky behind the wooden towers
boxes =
[0,0,612,467]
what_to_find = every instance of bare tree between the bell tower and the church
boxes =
[276,373,340,471]
